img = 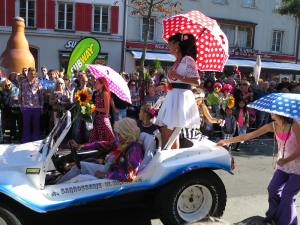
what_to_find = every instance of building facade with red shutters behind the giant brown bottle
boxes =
[0,0,123,71]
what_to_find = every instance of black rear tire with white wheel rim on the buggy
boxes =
[156,170,227,225]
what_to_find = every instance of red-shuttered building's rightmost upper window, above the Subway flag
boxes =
[93,5,110,33]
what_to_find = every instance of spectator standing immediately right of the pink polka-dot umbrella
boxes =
[127,80,141,119]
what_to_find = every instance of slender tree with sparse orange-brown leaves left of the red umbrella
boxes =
[129,0,181,79]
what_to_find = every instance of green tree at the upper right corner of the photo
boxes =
[277,0,300,63]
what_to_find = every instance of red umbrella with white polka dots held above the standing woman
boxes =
[163,11,229,71]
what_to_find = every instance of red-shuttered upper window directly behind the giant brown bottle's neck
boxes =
[19,0,35,27]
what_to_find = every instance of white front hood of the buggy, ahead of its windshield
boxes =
[0,140,43,168]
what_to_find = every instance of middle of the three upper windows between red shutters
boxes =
[57,2,74,30]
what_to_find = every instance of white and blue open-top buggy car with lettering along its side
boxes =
[0,112,233,225]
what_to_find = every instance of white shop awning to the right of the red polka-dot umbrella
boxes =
[226,59,300,71]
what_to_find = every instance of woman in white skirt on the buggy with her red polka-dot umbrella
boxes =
[157,11,229,149]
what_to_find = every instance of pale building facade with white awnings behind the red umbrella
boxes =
[126,0,300,79]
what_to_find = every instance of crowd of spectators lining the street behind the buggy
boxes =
[0,67,300,146]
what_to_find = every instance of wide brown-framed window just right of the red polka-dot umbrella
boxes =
[220,24,254,48]
